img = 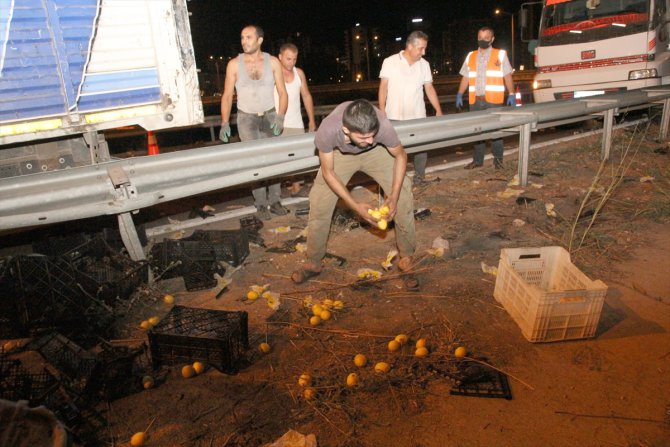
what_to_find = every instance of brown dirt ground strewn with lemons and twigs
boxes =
[7,121,670,447]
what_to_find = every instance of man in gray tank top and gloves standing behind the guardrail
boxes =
[219,25,288,220]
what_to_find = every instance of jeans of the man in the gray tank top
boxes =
[237,109,281,208]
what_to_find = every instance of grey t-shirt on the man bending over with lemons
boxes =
[314,101,400,154]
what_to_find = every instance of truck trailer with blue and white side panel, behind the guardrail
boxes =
[0,0,203,178]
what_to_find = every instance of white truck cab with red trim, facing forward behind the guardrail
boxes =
[533,0,670,102]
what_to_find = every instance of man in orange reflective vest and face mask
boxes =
[456,27,516,169]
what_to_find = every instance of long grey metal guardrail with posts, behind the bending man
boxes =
[0,85,670,259]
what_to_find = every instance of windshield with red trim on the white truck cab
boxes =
[539,0,650,46]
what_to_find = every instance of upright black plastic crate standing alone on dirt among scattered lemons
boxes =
[149,306,249,374]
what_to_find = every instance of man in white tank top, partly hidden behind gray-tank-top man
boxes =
[275,43,316,197]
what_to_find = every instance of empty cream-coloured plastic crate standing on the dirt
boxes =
[493,247,607,342]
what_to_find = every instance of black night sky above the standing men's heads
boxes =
[188,0,524,61]
